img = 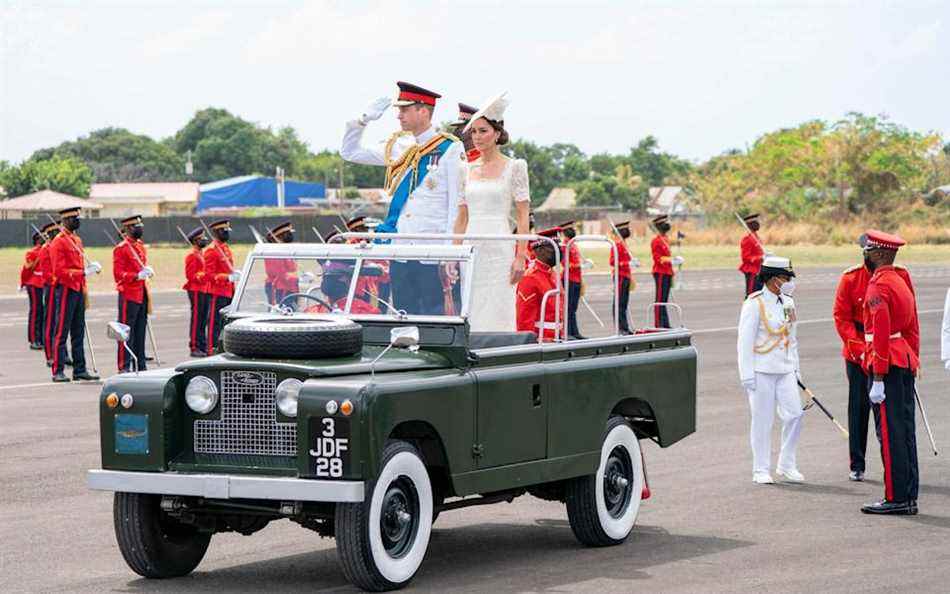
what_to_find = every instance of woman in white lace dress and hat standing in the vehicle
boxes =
[454,93,531,332]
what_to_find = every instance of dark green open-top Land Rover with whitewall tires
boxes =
[88,235,696,591]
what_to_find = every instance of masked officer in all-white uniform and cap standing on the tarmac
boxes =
[737,256,805,484]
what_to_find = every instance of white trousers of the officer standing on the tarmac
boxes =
[749,371,802,472]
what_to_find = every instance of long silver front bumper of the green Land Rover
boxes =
[86,469,364,503]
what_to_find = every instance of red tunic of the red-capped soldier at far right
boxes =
[864,266,920,375]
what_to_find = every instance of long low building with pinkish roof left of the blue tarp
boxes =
[89,182,200,219]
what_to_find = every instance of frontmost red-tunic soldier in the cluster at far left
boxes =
[49,208,102,382]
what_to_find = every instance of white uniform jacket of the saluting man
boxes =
[340,120,466,244]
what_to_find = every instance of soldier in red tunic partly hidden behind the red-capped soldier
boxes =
[833,229,914,481]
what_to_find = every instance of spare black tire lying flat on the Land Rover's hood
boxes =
[222,315,363,359]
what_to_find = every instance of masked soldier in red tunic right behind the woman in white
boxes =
[515,228,565,342]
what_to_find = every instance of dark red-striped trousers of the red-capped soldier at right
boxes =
[868,365,919,501]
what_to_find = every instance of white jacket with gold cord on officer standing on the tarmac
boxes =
[737,289,798,381]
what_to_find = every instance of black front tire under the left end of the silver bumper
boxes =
[112,493,211,579]
